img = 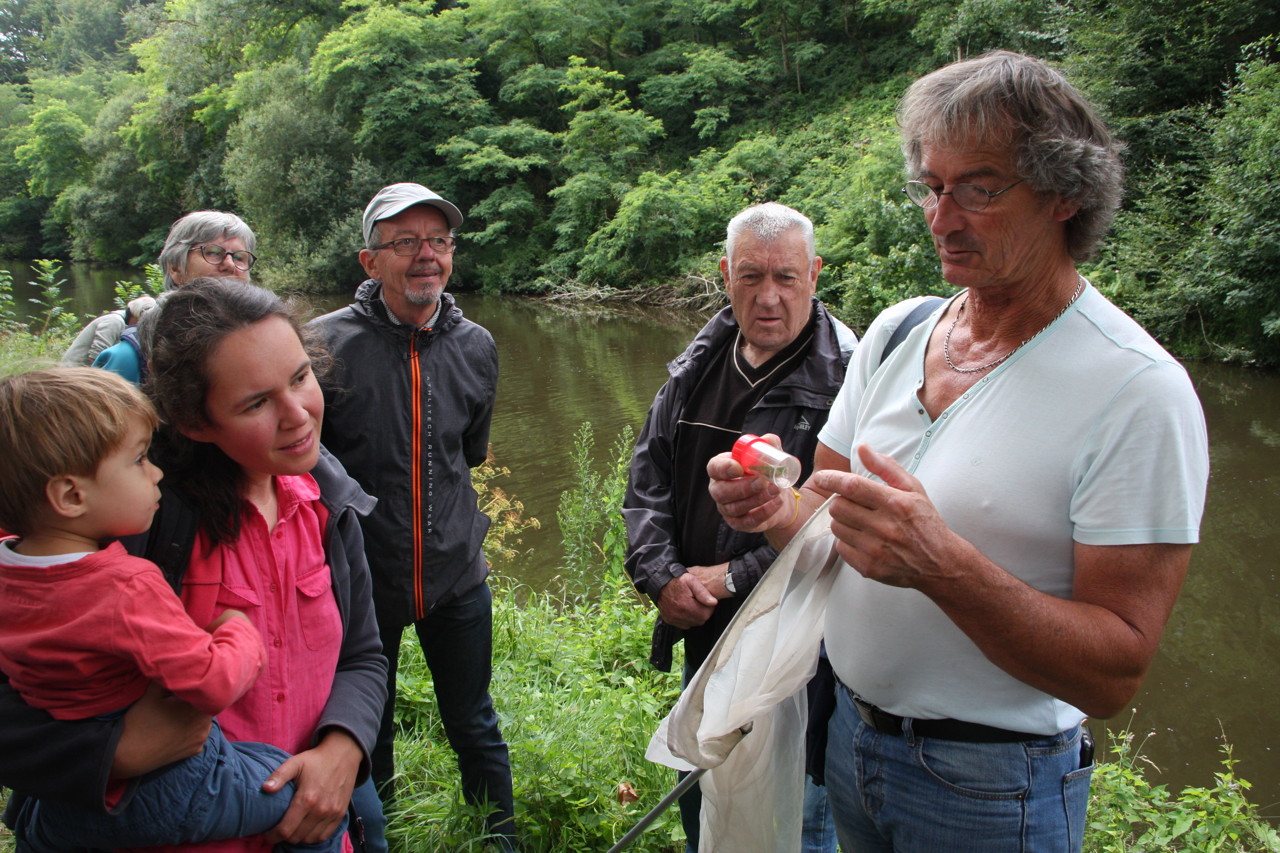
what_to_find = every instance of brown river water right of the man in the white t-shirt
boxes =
[1126,365,1280,818]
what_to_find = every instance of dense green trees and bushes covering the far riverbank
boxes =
[0,0,1280,365]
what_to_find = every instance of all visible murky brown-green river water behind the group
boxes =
[14,263,1280,818]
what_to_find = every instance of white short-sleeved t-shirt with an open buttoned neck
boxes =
[819,287,1208,735]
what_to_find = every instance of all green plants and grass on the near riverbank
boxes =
[0,350,1280,853]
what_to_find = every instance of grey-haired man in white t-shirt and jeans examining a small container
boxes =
[708,53,1208,853]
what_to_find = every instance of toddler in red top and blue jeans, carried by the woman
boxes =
[0,368,344,853]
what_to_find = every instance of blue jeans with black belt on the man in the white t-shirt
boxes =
[827,688,1093,853]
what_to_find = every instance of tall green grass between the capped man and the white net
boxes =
[389,427,684,853]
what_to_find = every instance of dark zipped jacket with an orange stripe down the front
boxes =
[311,280,498,625]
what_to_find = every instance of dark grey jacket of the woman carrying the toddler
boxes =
[0,450,387,815]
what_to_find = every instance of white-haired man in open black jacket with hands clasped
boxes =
[622,204,858,852]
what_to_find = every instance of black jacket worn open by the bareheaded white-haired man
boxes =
[622,300,858,671]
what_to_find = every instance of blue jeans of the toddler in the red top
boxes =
[15,720,347,853]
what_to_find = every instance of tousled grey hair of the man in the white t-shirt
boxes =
[897,50,1124,261]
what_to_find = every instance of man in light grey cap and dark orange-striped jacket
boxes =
[312,183,516,850]
